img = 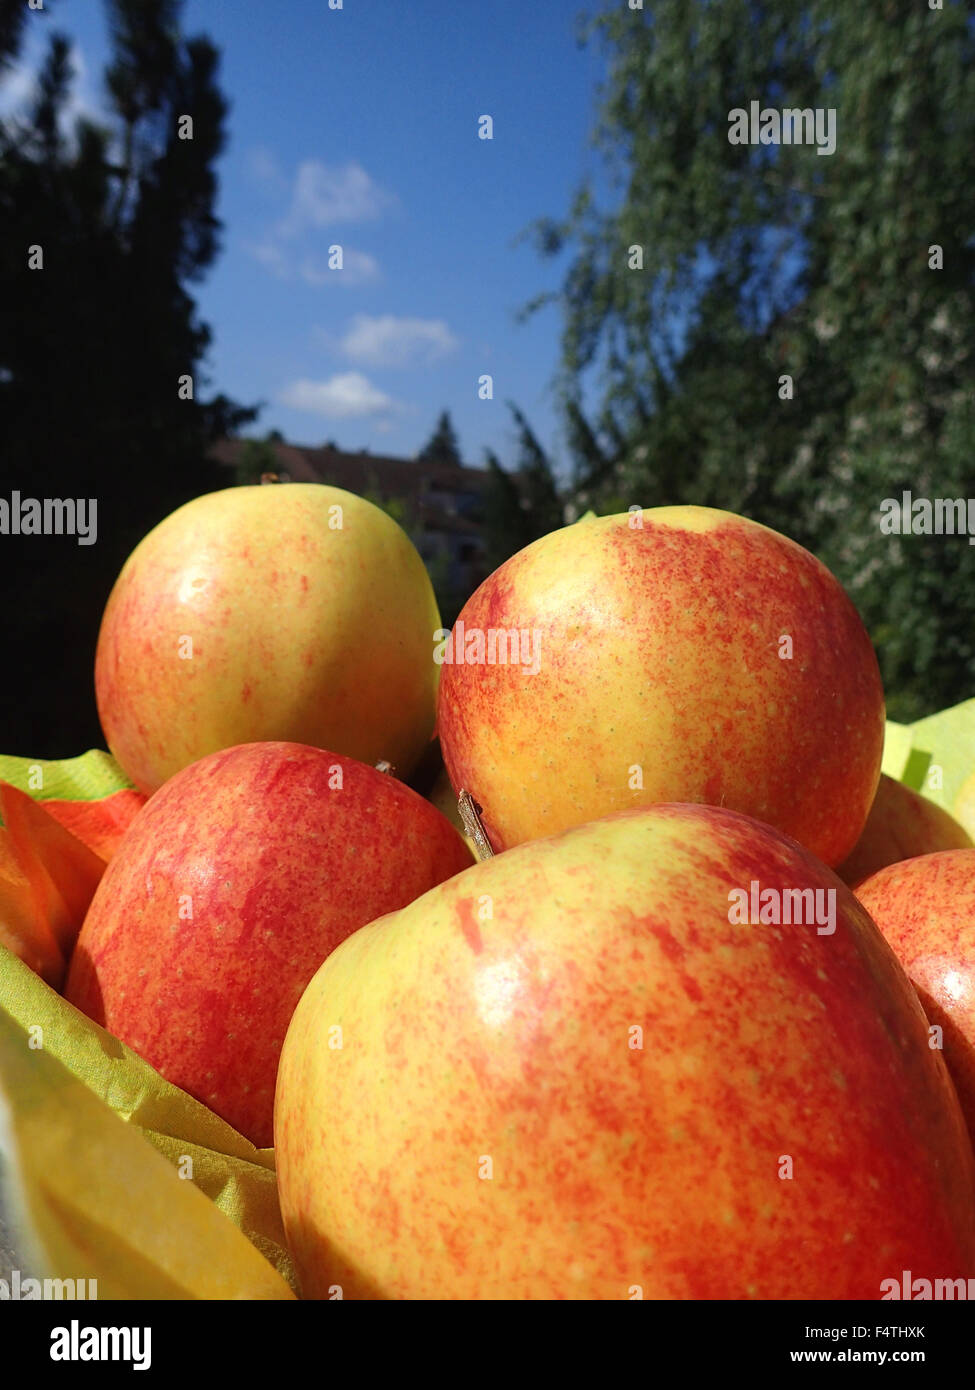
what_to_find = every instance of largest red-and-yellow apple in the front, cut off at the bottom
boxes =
[274,806,975,1300]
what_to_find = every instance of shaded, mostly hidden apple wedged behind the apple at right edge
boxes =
[836,773,972,887]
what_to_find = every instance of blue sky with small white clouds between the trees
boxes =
[0,0,605,466]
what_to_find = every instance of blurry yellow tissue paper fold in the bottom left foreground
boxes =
[0,948,293,1298]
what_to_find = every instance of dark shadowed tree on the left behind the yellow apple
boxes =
[0,0,256,756]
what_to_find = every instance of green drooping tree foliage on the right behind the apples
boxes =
[526,0,975,719]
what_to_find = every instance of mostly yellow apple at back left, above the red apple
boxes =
[95,482,440,792]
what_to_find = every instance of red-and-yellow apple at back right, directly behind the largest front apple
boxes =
[438,507,885,865]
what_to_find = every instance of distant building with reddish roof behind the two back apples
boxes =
[211,439,491,611]
